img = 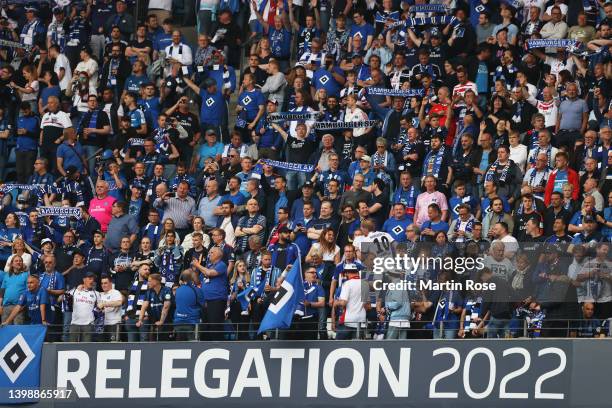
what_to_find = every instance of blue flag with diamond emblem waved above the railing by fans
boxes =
[257,258,304,334]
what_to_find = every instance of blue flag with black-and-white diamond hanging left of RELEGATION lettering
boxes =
[0,325,47,405]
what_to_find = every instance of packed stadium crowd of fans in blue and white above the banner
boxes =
[0,0,612,341]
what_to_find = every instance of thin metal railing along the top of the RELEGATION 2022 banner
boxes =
[13,319,612,342]
